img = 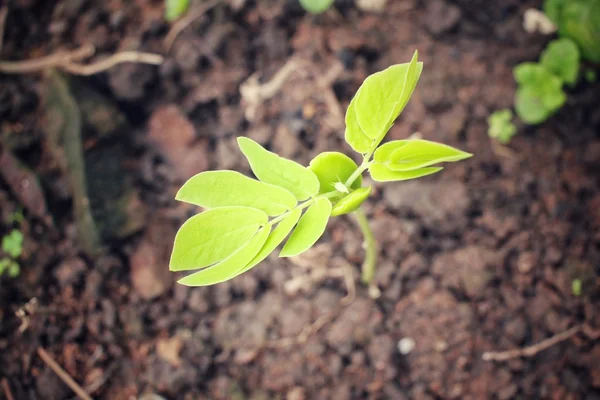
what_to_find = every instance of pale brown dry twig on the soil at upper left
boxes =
[0,44,164,76]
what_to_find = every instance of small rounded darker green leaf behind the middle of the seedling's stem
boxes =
[308,151,362,194]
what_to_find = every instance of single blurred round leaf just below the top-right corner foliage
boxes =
[540,38,579,84]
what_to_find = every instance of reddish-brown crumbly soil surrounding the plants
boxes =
[0,0,600,400]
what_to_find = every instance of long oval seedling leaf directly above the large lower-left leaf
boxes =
[175,171,297,216]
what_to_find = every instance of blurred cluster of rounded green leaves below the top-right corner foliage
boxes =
[513,38,579,125]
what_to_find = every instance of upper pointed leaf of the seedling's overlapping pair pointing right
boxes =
[387,140,473,171]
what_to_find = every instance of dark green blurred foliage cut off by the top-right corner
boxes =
[544,0,600,63]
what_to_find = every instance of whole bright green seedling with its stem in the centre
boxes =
[170,52,471,286]
